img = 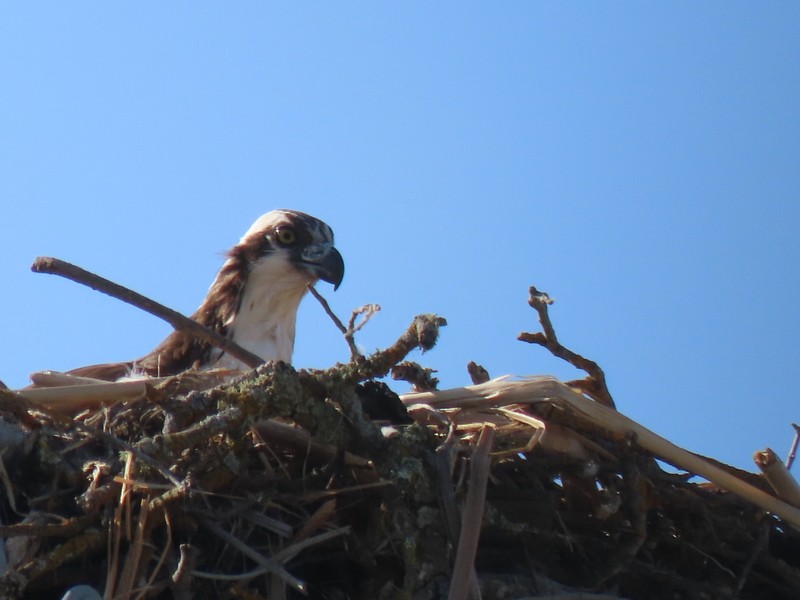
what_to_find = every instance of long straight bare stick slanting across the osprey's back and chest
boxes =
[31,256,264,368]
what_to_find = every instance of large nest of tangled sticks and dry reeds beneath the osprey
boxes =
[0,274,800,600]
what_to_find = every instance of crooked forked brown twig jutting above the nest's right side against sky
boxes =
[517,286,615,408]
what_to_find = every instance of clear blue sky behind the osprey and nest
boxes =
[0,1,800,469]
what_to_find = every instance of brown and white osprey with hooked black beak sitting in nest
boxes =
[69,209,344,381]
